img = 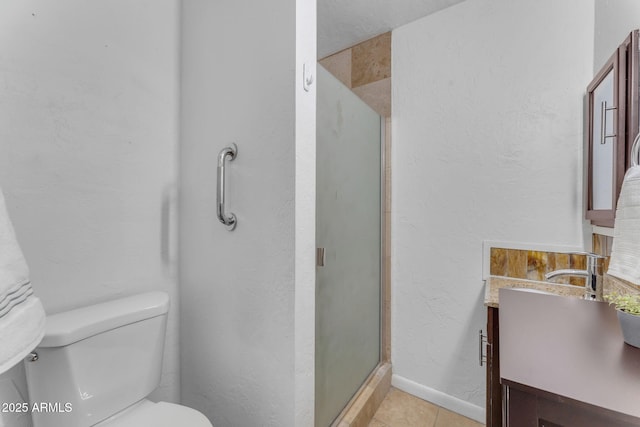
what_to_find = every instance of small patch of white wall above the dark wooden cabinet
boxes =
[593,0,640,74]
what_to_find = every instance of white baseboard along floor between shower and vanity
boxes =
[391,375,485,424]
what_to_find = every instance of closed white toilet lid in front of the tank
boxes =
[95,401,212,427]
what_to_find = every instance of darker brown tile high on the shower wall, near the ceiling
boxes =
[351,32,391,88]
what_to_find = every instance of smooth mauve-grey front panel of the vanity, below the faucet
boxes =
[500,289,640,417]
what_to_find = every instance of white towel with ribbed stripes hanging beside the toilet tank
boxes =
[0,190,45,373]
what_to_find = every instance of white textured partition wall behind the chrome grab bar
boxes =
[180,0,315,426]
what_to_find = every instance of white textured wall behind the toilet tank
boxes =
[0,0,179,424]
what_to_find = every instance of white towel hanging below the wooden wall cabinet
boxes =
[607,166,640,285]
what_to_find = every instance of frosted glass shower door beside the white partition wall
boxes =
[315,66,381,427]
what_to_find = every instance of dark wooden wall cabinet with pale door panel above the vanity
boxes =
[585,30,640,227]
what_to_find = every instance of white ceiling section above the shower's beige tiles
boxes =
[318,0,464,58]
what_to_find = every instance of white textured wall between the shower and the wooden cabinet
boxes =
[391,0,594,420]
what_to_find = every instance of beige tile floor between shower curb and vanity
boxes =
[369,387,484,427]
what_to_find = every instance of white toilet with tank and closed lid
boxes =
[25,292,212,427]
